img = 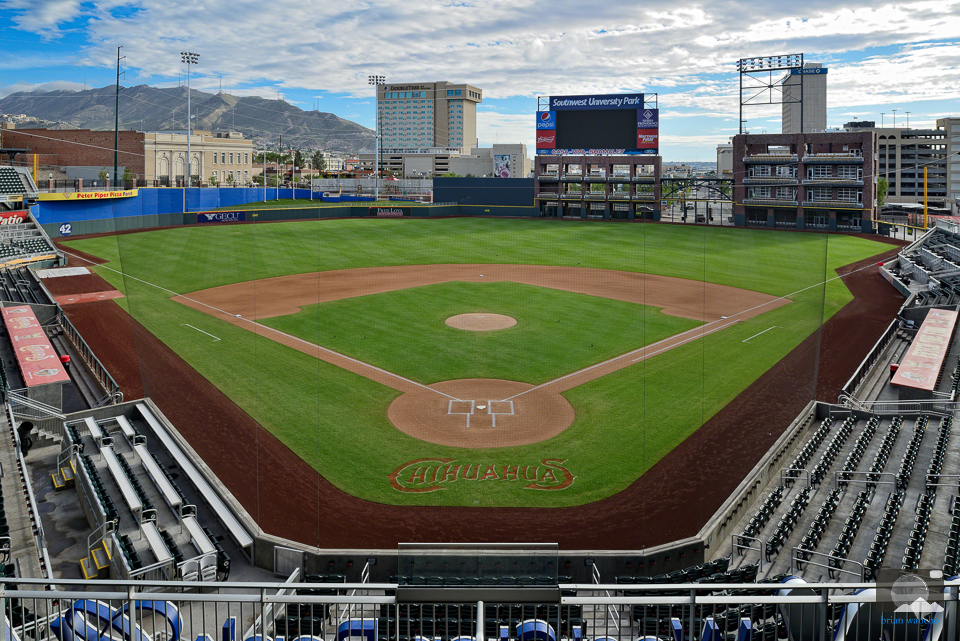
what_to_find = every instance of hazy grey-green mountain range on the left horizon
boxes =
[0,85,376,154]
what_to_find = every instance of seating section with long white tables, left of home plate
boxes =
[62,403,249,582]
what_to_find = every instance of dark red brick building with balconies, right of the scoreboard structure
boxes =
[733,131,877,232]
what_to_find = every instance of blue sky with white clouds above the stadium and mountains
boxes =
[0,0,960,162]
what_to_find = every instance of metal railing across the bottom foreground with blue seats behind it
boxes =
[0,579,960,641]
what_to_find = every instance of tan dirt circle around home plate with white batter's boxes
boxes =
[387,378,575,448]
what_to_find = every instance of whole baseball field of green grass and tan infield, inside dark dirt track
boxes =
[56,219,891,507]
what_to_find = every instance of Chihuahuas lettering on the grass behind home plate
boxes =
[387,458,577,493]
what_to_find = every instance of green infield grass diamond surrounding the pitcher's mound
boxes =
[260,282,700,385]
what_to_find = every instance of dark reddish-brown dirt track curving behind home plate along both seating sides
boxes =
[65,242,903,550]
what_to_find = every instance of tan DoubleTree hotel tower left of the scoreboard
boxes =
[377,82,483,153]
